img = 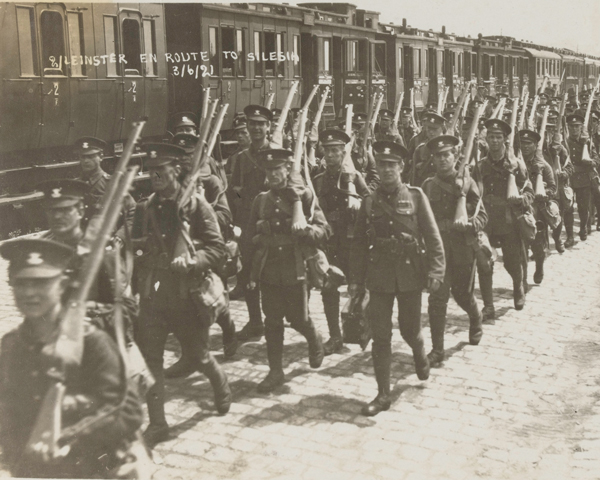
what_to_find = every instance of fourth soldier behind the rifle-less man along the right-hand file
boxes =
[544,123,575,249]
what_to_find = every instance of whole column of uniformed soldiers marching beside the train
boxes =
[0,82,600,476]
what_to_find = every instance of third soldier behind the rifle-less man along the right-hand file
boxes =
[519,130,556,285]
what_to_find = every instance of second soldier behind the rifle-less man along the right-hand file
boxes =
[475,119,533,310]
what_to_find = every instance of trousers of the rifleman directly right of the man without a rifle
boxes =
[427,259,481,353]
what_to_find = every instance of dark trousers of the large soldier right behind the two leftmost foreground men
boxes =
[139,300,218,425]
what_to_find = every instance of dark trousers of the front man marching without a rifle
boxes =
[367,290,424,394]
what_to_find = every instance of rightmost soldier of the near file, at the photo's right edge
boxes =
[566,114,600,241]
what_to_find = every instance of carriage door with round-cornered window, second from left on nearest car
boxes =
[118,9,145,138]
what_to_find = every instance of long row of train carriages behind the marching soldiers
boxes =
[0,3,600,238]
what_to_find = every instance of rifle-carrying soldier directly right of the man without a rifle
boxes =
[423,135,487,367]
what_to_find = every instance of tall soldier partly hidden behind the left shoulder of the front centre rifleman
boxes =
[230,105,274,342]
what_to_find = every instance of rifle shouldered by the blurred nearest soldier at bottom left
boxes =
[22,164,141,461]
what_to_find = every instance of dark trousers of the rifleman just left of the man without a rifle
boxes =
[260,283,317,370]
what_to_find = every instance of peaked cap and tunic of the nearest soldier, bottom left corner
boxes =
[0,239,143,478]
